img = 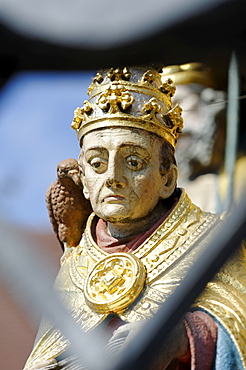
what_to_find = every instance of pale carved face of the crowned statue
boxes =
[81,128,176,223]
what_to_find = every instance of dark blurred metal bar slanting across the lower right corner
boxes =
[114,191,246,370]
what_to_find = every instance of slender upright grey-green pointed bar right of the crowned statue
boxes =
[223,52,240,211]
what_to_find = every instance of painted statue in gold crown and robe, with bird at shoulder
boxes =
[25,67,246,370]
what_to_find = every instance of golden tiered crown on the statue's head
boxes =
[71,67,183,147]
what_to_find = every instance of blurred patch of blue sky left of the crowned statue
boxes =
[0,71,94,229]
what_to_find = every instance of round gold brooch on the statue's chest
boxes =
[84,253,146,313]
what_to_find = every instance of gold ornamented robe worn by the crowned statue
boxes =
[25,190,246,370]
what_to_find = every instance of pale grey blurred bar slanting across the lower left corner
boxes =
[0,221,108,370]
